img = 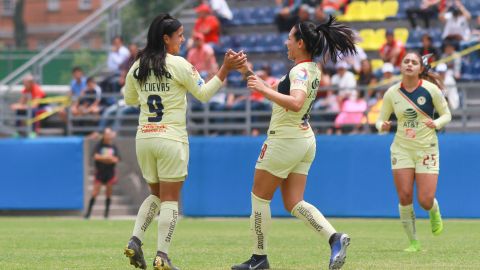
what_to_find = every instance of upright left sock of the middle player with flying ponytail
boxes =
[250,192,272,255]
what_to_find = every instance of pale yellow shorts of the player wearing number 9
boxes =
[136,138,189,184]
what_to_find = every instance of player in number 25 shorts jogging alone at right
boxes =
[376,52,451,252]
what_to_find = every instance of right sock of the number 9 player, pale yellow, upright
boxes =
[157,201,178,254]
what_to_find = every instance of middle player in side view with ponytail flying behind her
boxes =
[232,17,356,270]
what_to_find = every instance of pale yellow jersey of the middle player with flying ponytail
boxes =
[268,62,321,138]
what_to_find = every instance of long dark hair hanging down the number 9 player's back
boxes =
[134,13,182,83]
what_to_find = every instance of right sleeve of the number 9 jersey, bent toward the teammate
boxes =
[176,57,223,102]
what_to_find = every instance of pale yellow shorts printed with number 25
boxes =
[390,143,440,174]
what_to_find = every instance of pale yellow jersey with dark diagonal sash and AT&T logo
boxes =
[376,80,451,149]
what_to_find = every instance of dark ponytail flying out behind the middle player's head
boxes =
[295,15,357,63]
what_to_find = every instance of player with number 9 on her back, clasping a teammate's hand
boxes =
[125,14,246,270]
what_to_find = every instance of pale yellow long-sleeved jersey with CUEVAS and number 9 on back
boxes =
[125,54,222,143]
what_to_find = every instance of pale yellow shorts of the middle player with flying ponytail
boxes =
[255,136,317,179]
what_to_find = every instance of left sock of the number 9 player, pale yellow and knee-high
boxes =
[132,195,160,242]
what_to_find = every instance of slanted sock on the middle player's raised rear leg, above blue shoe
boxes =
[291,201,336,240]
